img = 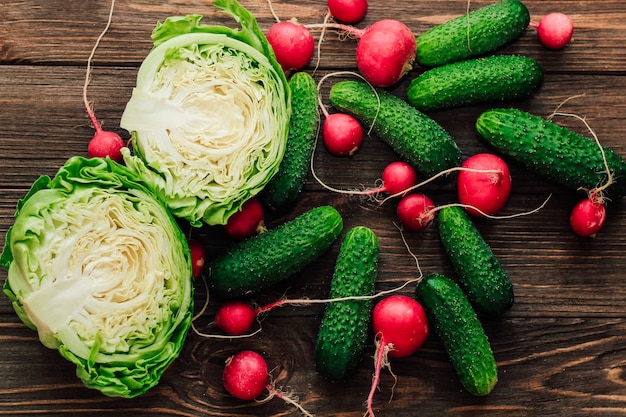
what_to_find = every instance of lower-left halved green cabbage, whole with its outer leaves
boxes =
[0,157,193,397]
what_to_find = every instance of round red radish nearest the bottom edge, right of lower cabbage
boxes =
[222,350,269,401]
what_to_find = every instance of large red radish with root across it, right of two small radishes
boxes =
[457,153,511,217]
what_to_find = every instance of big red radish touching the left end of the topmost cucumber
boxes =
[356,19,417,87]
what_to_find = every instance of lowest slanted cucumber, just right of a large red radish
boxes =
[415,274,498,397]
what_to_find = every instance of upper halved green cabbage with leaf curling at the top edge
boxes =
[121,0,291,226]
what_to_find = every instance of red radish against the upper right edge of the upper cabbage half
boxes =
[267,19,315,71]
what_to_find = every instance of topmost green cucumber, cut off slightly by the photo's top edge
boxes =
[416,0,530,67]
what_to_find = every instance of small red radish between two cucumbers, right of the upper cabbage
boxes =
[322,113,363,156]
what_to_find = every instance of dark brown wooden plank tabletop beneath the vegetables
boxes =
[0,0,626,417]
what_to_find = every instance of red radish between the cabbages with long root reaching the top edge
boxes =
[83,0,125,162]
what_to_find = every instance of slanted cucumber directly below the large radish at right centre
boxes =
[438,206,514,316]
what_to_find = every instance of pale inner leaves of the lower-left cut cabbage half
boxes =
[23,188,185,358]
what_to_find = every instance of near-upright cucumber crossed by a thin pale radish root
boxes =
[315,226,379,381]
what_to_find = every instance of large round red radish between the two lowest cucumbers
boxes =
[372,294,428,358]
